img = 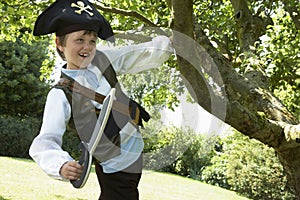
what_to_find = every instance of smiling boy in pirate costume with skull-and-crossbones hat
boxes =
[29,0,172,200]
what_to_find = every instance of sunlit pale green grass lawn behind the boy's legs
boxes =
[0,157,247,200]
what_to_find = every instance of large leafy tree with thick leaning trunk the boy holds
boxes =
[0,0,300,199]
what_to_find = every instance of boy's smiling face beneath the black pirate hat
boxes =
[56,30,97,69]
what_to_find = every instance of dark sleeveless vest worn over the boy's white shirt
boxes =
[54,51,150,162]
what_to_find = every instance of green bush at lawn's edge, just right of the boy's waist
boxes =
[142,119,216,179]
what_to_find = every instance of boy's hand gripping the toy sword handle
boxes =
[60,161,83,180]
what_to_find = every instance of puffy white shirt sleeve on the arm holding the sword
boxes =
[29,88,73,180]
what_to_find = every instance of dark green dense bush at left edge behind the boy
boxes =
[0,39,49,116]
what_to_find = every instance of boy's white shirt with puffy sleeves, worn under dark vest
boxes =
[29,36,174,180]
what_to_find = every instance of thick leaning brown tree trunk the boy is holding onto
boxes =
[171,0,300,199]
